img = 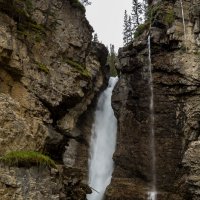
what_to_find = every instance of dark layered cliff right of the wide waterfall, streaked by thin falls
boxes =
[106,0,200,200]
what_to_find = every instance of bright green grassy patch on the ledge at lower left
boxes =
[0,151,56,168]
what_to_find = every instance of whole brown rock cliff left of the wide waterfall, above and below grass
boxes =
[0,0,107,200]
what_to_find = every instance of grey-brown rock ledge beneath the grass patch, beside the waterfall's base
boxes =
[0,166,91,200]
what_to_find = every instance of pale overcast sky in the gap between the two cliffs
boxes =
[86,0,132,52]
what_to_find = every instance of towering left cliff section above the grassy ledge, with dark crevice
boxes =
[0,0,107,157]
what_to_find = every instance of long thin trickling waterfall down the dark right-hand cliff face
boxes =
[148,34,157,200]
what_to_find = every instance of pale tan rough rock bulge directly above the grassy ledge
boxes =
[0,93,47,155]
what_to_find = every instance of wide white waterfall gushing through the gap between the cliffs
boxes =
[87,77,118,200]
